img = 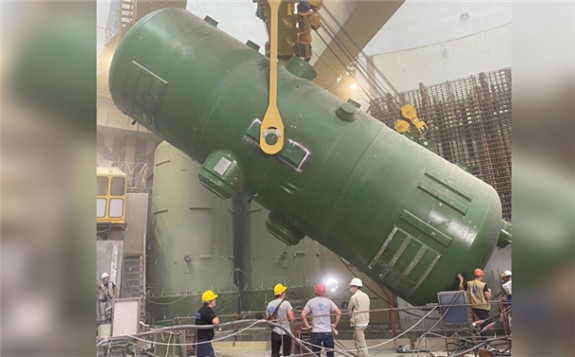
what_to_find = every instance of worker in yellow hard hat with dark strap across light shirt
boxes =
[266,284,293,357]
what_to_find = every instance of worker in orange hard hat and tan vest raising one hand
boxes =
[457,268,495,331]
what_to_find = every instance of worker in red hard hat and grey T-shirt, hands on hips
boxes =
[301,283,341,357]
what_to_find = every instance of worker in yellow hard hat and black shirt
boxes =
[195,290,220,357]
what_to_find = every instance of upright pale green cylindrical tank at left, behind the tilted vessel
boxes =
[151,142,235,300]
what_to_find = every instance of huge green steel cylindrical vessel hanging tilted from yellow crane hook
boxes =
[110,9,501,304]
